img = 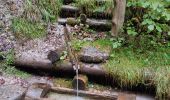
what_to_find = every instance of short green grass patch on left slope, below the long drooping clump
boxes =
[12,18,46,39]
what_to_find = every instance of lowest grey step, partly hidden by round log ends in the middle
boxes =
[58,18,111,31]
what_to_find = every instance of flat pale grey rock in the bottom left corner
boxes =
[0,85,26,100]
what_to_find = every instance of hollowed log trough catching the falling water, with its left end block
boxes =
[25,83,118,100]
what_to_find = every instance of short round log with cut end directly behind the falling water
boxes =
[72,74,88,90]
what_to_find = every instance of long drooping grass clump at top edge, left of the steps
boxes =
[24,0,62,22]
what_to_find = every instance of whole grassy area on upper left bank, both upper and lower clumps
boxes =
[12,0,62,39]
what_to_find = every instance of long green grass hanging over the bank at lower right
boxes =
[106,47,170,98]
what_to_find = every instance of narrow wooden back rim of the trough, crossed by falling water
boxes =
[51,87,117,100]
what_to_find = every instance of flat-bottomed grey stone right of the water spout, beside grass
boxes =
[79,47,109,63]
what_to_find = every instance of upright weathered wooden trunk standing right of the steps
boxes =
[112,0,126,37]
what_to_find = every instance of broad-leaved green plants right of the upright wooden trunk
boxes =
[124,0,170,51]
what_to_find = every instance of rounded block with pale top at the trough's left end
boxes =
[25,83,51,100]
